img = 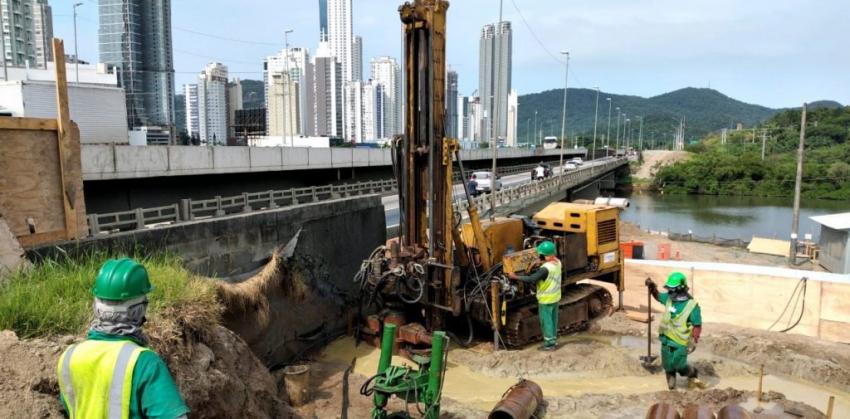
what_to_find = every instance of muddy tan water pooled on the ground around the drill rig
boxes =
[319,335,850,418]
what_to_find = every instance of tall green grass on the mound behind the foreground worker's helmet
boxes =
[0,254,218,338]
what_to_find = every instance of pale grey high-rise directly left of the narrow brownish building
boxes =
[196,63,228,145]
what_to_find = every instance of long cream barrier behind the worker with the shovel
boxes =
[608,259,850,343]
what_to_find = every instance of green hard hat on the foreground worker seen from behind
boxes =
[92,258,153,301]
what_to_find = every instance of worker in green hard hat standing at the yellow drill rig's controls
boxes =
[508,240,561,351]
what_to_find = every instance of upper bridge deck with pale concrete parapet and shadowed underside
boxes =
[81,145,586,212]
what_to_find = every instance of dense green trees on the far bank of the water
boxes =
[653,107,850,200]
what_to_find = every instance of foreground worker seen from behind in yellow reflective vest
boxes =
[56,259,189,419]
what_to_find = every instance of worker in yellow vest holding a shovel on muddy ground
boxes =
[646,272,704,390]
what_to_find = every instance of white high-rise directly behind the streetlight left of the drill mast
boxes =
[263,47,313,135]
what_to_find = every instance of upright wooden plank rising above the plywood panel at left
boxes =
[53,38,77,240]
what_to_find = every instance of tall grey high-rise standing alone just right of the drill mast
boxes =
[478,21,512,141]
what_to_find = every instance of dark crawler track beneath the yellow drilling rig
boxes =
[502,284,614,348]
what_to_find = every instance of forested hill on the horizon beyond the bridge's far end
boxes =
[517,87,777,148]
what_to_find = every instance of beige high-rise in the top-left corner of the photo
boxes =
[0,0,53,68]
